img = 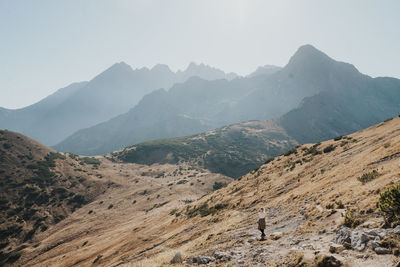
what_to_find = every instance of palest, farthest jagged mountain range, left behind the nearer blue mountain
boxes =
[0,62,236,145]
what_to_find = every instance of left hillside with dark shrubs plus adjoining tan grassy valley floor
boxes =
[0,131,231,266]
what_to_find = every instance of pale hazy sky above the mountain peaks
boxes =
[0,0,400,108]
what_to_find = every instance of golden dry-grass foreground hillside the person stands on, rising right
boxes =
[15,115,400,266]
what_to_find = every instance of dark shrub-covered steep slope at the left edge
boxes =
[0,131,107,265]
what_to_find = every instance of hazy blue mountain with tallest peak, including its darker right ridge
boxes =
[55,45,400,158]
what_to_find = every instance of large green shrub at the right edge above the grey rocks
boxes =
[377,184,400,223]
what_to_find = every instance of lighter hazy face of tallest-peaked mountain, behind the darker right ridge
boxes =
[55,45,360,155]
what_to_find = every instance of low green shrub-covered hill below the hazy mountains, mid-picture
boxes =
[112,120,298,178]
